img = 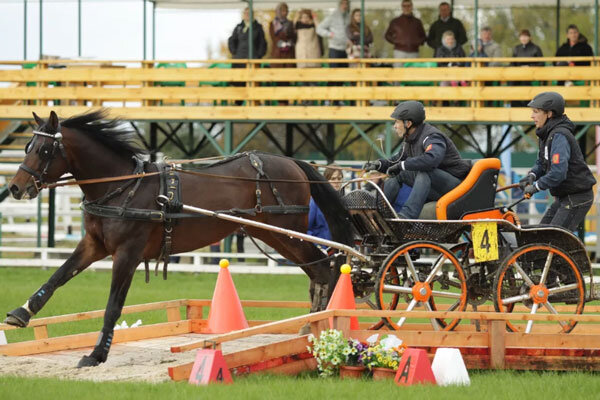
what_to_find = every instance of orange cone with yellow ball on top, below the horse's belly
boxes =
[208,259,248,333]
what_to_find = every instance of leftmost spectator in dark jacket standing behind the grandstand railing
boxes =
[227,7,267,61]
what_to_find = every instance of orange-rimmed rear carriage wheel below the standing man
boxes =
[493,244,585,333]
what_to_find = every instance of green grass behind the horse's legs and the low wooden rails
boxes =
[0,268,309,342]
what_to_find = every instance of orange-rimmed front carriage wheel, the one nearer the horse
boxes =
[375,242,467,331]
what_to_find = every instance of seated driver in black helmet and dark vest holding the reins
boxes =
[363,101,471,219]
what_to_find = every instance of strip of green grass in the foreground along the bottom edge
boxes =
[0,371,600,400]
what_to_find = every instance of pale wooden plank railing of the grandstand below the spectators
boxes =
[0,57,600,122]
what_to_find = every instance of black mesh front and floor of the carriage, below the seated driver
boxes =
[343,190,470,243]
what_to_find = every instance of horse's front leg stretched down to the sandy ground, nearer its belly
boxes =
[77,251,141,368]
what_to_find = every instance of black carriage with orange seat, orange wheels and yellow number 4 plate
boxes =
[344,159,594,333]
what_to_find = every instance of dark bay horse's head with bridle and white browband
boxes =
[8,111,69,200]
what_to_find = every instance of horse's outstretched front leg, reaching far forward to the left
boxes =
[4,234,107,328]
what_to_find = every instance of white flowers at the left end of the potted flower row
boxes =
[308,329,352,377]
